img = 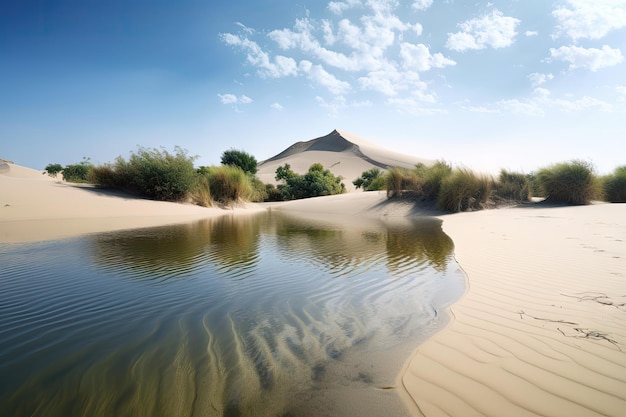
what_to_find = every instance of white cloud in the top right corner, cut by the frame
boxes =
[552,0,626,41]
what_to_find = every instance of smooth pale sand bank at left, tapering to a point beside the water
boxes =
[0,163,258,243]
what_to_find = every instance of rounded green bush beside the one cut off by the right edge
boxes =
[537,161,603,204]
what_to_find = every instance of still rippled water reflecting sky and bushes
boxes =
[0,212,465,417]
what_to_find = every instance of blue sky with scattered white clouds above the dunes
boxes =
[0,0,626,173]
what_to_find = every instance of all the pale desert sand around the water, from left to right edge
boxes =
[0,136,626,417]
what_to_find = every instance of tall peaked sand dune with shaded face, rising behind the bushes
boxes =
[257,130,433,191]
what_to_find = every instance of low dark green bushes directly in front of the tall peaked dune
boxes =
[276,163,346,200]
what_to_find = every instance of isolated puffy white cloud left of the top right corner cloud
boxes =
[446,10,520,52]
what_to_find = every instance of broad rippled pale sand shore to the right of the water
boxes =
[402,204,626,417]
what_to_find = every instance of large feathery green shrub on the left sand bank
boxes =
[90,147,197,201]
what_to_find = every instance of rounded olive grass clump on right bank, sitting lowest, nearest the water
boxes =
[437,169,493,213]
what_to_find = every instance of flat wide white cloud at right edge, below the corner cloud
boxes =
[550,45,624,71]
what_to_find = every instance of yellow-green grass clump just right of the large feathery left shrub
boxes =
[199,165,253,204]
